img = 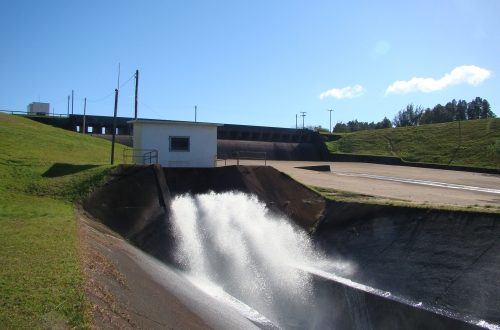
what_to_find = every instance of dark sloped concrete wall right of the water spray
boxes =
[315,202,500,328]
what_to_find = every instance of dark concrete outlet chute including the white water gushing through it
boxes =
[82,166,500,329]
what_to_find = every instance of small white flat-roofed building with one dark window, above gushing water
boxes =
[129,119,221,167]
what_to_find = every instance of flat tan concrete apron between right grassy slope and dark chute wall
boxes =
[219,160,500,207]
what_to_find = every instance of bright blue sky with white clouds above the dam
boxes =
[0,0,500,128]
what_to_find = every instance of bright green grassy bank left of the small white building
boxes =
[0,114,123,329]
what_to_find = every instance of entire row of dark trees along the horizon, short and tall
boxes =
[333,97,496,133]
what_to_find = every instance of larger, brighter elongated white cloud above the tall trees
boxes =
[385,65,491,95]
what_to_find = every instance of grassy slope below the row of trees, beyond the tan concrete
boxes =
[327,119,500,168]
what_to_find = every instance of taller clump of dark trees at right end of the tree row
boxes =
[392,97,495,127]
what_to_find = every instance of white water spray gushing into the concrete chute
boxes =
[172,192,346,328]
